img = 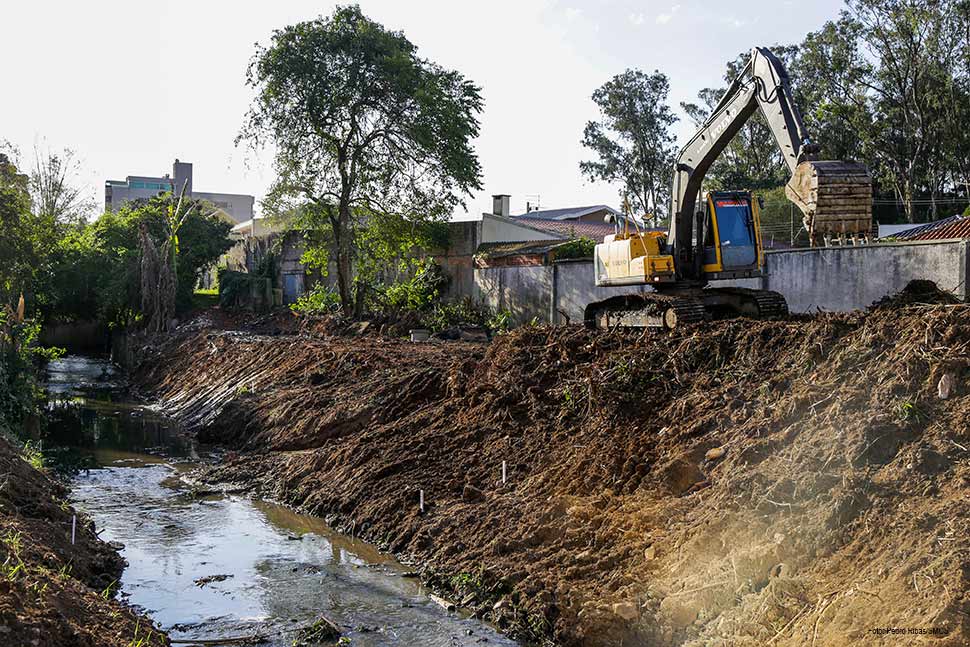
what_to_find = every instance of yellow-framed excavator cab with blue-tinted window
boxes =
[701,191,762,279]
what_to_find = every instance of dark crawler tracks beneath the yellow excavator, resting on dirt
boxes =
[584,288,788,330]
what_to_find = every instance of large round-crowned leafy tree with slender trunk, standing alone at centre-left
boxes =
[237,6,482,313]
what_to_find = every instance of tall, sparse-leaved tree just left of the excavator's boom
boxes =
[579,70,677,226]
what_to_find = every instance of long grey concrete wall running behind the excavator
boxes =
[473,240,970,323]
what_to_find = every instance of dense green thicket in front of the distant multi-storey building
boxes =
[0,154,231,327]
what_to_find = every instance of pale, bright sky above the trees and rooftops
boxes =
[0,0,843,218]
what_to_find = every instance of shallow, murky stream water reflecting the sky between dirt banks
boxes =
[45,356,515,646]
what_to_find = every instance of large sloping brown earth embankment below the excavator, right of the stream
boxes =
[134,295,970,646]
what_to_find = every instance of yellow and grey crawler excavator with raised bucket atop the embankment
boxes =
[585,47,872,329]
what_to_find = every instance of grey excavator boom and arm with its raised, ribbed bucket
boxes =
[668,47,872,280]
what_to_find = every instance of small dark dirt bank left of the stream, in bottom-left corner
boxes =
[0,438,169,647]
